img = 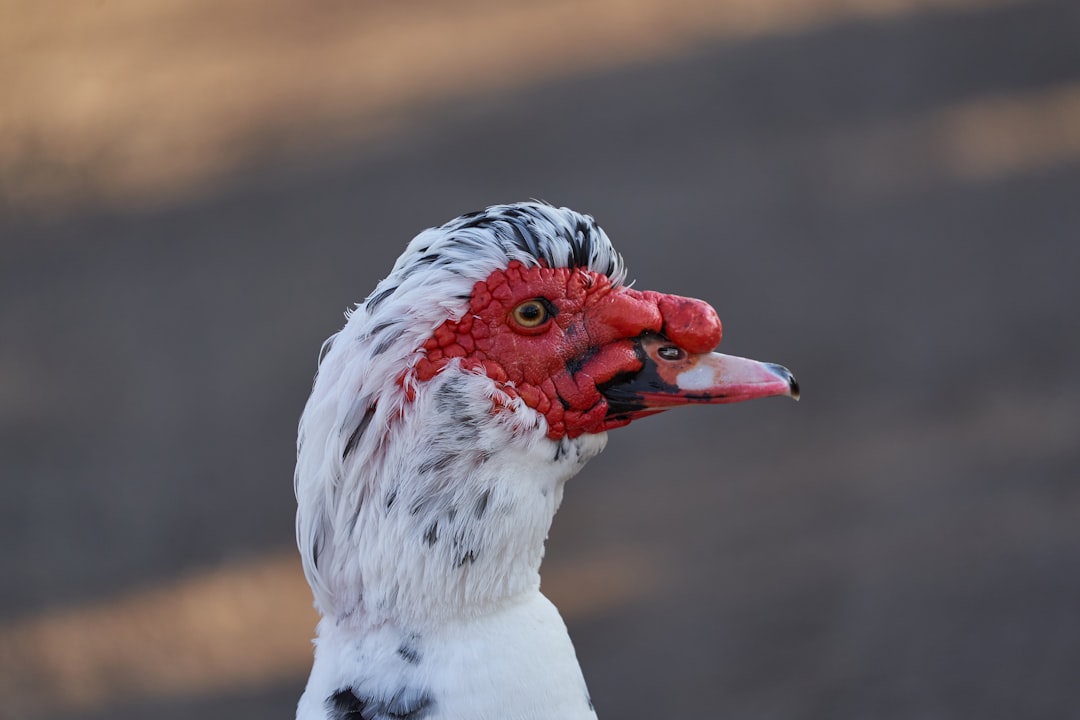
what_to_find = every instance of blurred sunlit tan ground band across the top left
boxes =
[0,0,1016,214]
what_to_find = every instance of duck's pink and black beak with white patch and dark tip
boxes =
[599,335,799,420]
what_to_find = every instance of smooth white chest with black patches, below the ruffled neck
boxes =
[297,592,596,720]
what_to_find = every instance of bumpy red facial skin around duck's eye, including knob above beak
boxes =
[415,260,721,439]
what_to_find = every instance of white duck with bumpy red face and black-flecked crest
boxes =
[294,201,799,720]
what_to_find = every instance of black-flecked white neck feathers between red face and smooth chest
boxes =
[300,362,606,627]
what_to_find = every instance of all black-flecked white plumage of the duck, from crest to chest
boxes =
[295,203,624,720]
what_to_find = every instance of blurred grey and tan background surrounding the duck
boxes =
[0,0,1080,720]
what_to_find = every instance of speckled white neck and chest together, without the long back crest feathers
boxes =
[297,372,607,720]
